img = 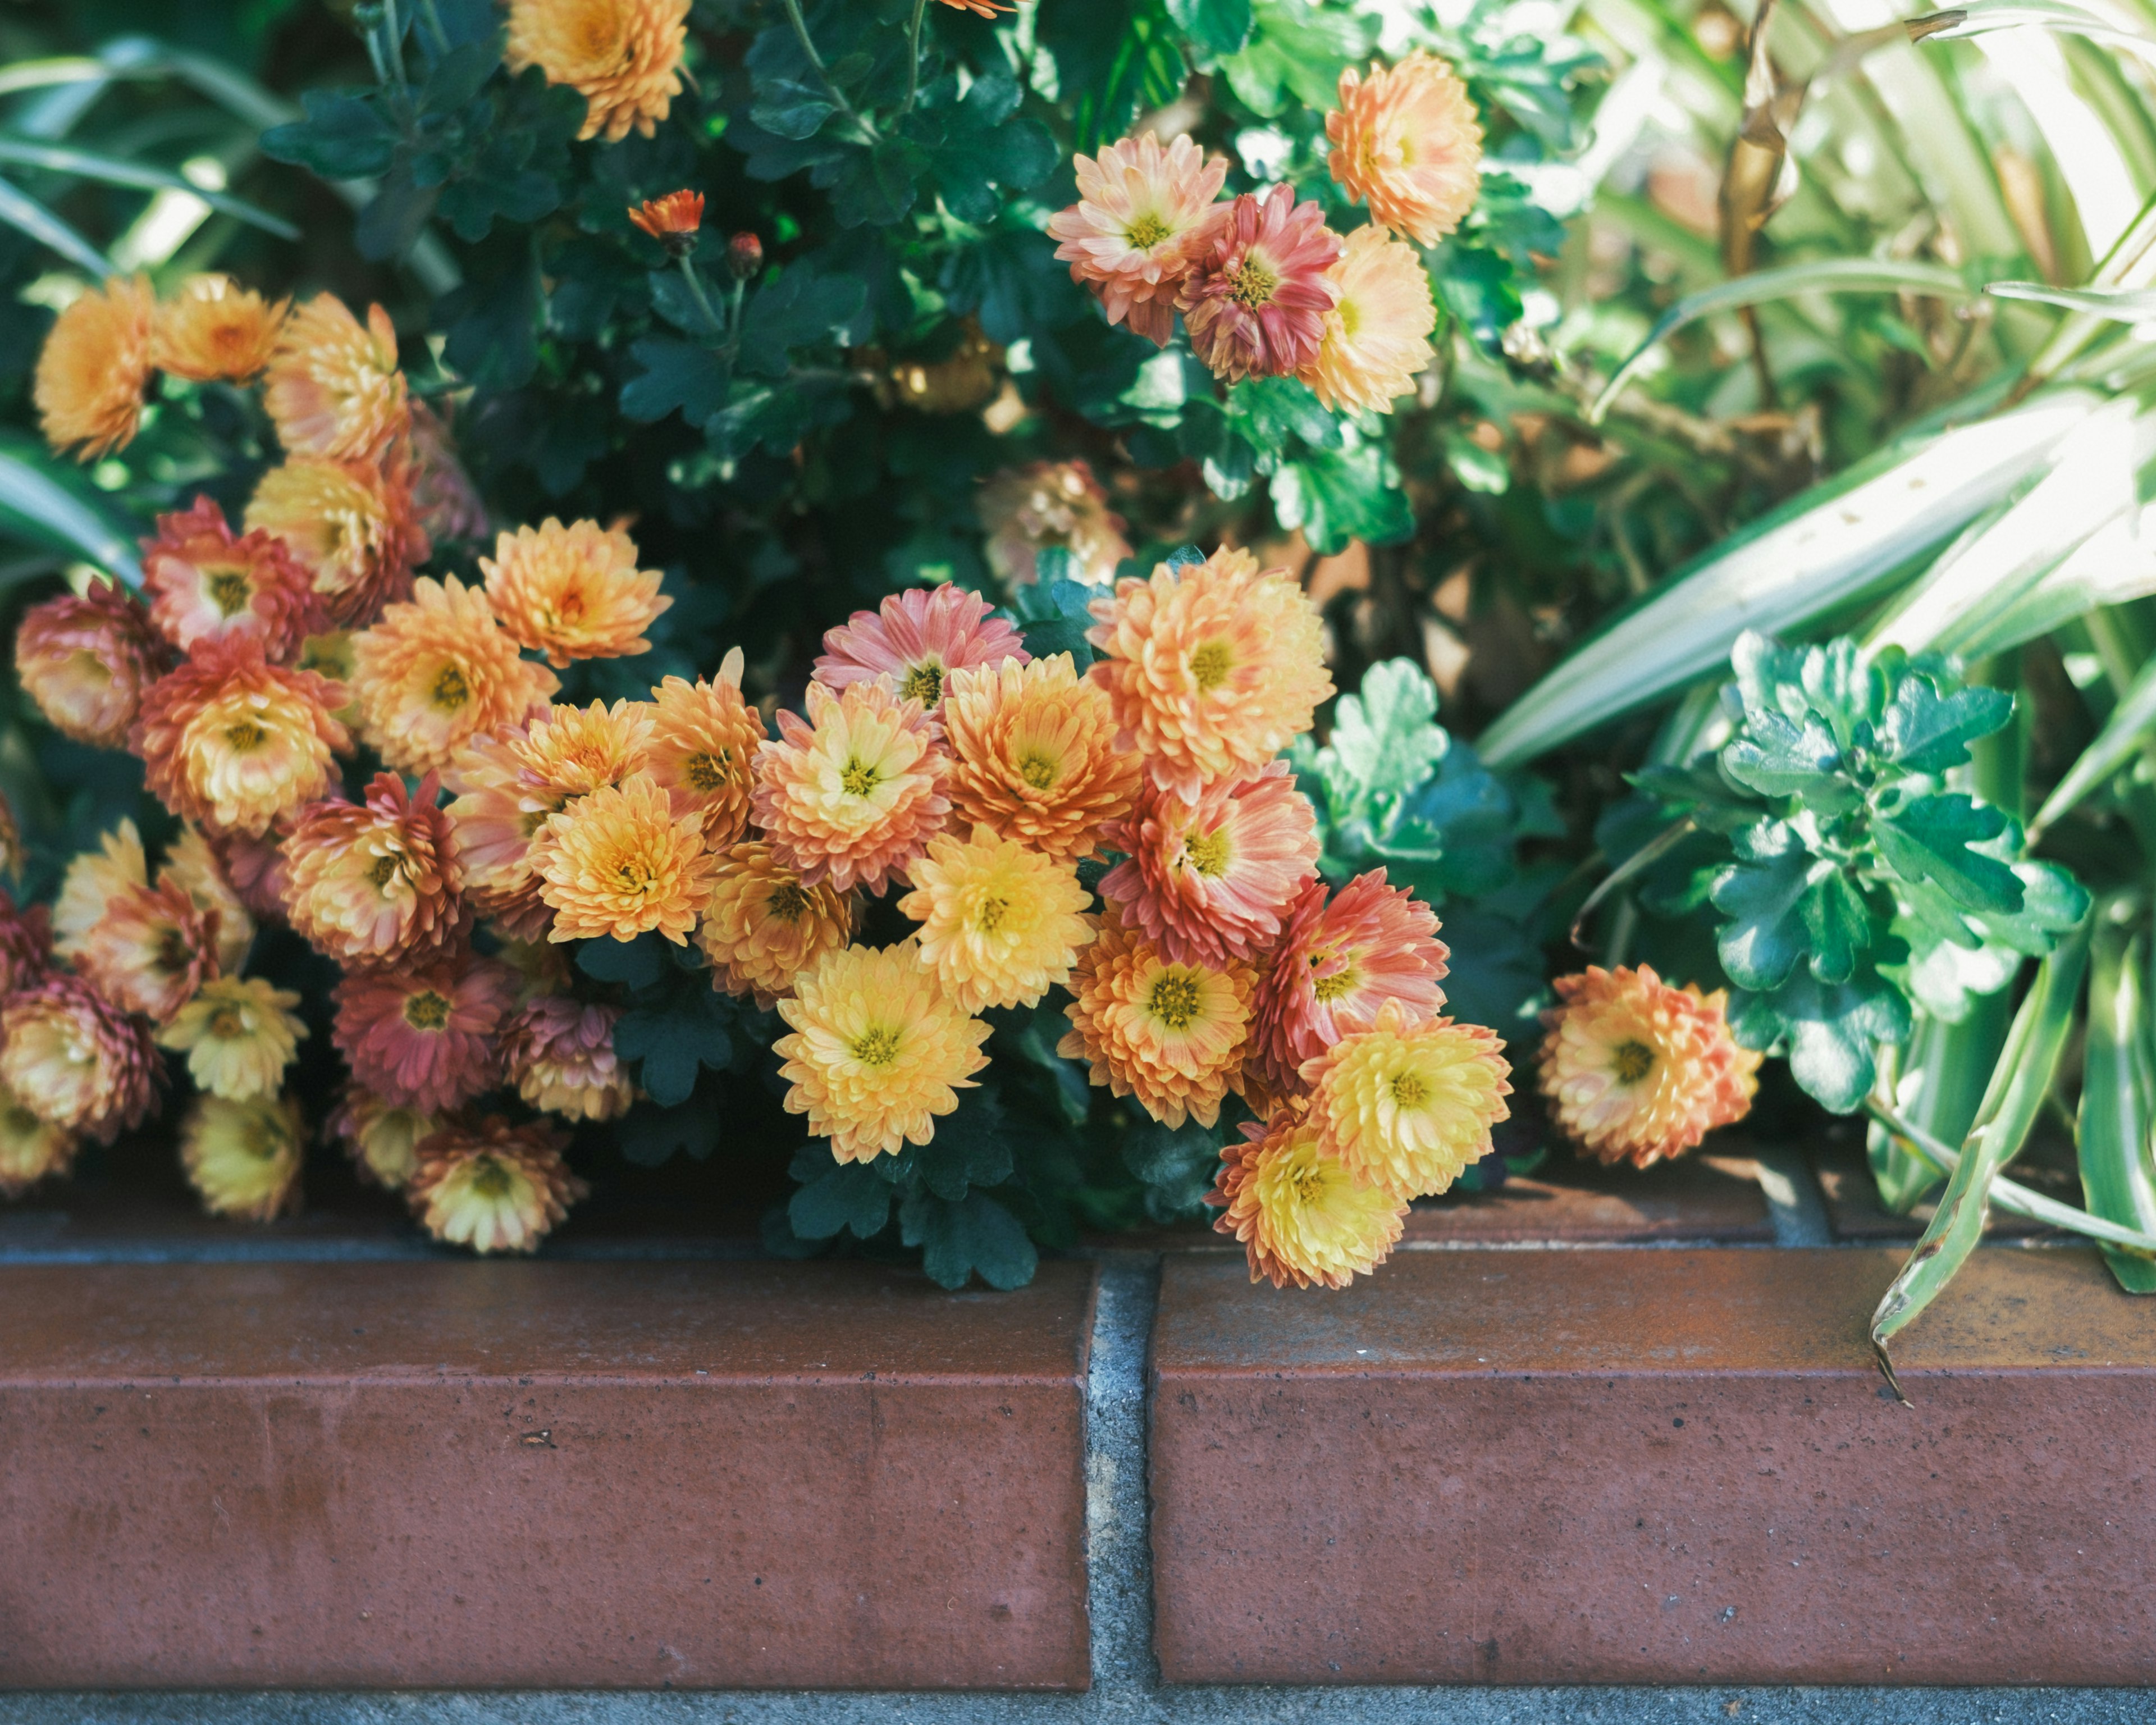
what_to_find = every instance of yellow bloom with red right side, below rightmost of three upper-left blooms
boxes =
[248,451,433,629]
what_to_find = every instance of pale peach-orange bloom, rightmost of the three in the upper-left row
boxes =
[263,293,412,462]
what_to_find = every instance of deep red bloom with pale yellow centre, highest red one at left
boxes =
[142,498,326,664]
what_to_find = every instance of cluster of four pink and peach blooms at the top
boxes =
[1048,52,1481,412]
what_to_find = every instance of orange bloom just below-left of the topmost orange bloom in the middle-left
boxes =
[351,576,560,772]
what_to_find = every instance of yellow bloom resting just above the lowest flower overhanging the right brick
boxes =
[1302,1001,1511,1199]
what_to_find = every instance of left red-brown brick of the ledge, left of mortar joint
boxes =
[0,1263,1091,1689]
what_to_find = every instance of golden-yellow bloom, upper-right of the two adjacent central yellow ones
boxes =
[899,826,1093,1011]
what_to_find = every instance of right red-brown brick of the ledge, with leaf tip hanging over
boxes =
[1152,1248,2156,1684]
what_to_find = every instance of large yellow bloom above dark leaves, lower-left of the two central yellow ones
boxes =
[772,940,988,1162]
